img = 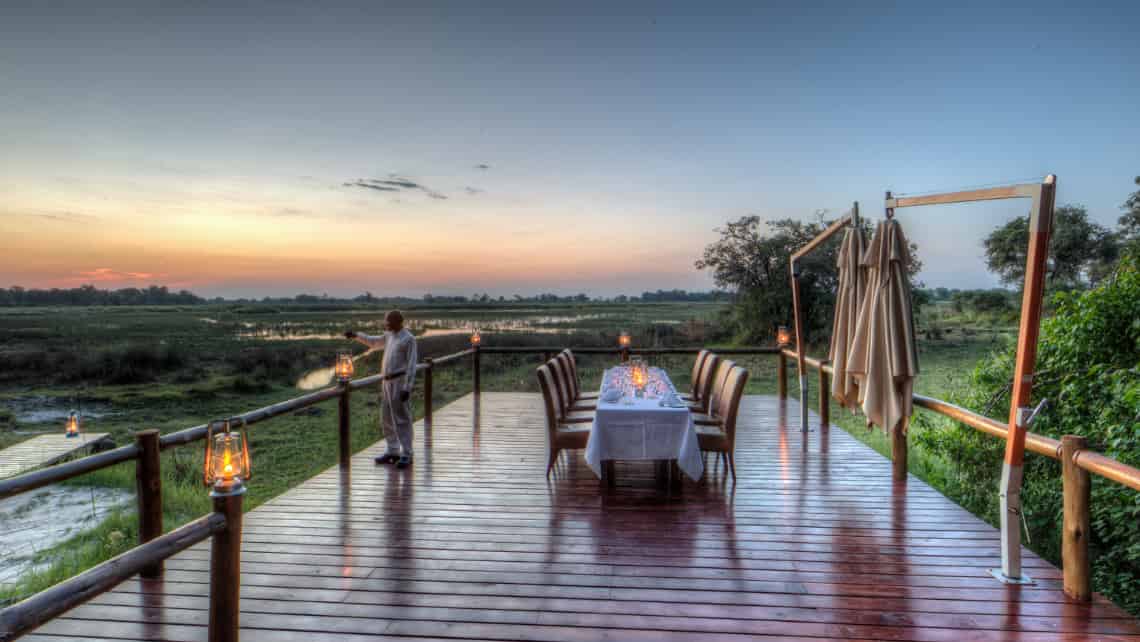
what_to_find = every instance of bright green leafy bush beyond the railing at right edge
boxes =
[914,257,1140,613]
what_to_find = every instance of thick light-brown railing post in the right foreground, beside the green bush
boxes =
[1061,434,1092,602]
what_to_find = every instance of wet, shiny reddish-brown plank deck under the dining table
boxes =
[17,393,1140,642]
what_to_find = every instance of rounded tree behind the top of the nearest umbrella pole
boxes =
[983,205,1119,289]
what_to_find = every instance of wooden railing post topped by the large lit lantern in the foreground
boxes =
[209,493,242,642]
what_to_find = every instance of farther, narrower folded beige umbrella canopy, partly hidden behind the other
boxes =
[828,227,866,408]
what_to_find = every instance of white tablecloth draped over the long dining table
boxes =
[586,366,705,481]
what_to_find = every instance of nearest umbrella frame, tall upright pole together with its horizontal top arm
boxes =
[884,174,1057,584]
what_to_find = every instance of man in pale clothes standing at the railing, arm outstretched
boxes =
[344,310,417,469]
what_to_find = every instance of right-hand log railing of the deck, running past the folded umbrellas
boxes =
[776,350,1140,602]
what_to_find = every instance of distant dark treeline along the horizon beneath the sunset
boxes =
[0,285,731,307]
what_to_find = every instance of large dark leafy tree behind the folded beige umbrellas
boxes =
[697,216,922,342]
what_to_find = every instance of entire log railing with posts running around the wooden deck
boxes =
[0,346,1140,642]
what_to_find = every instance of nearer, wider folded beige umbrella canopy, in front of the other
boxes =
[846,219,919,431]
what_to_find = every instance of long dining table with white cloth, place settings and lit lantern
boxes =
[586,365,705,481]
